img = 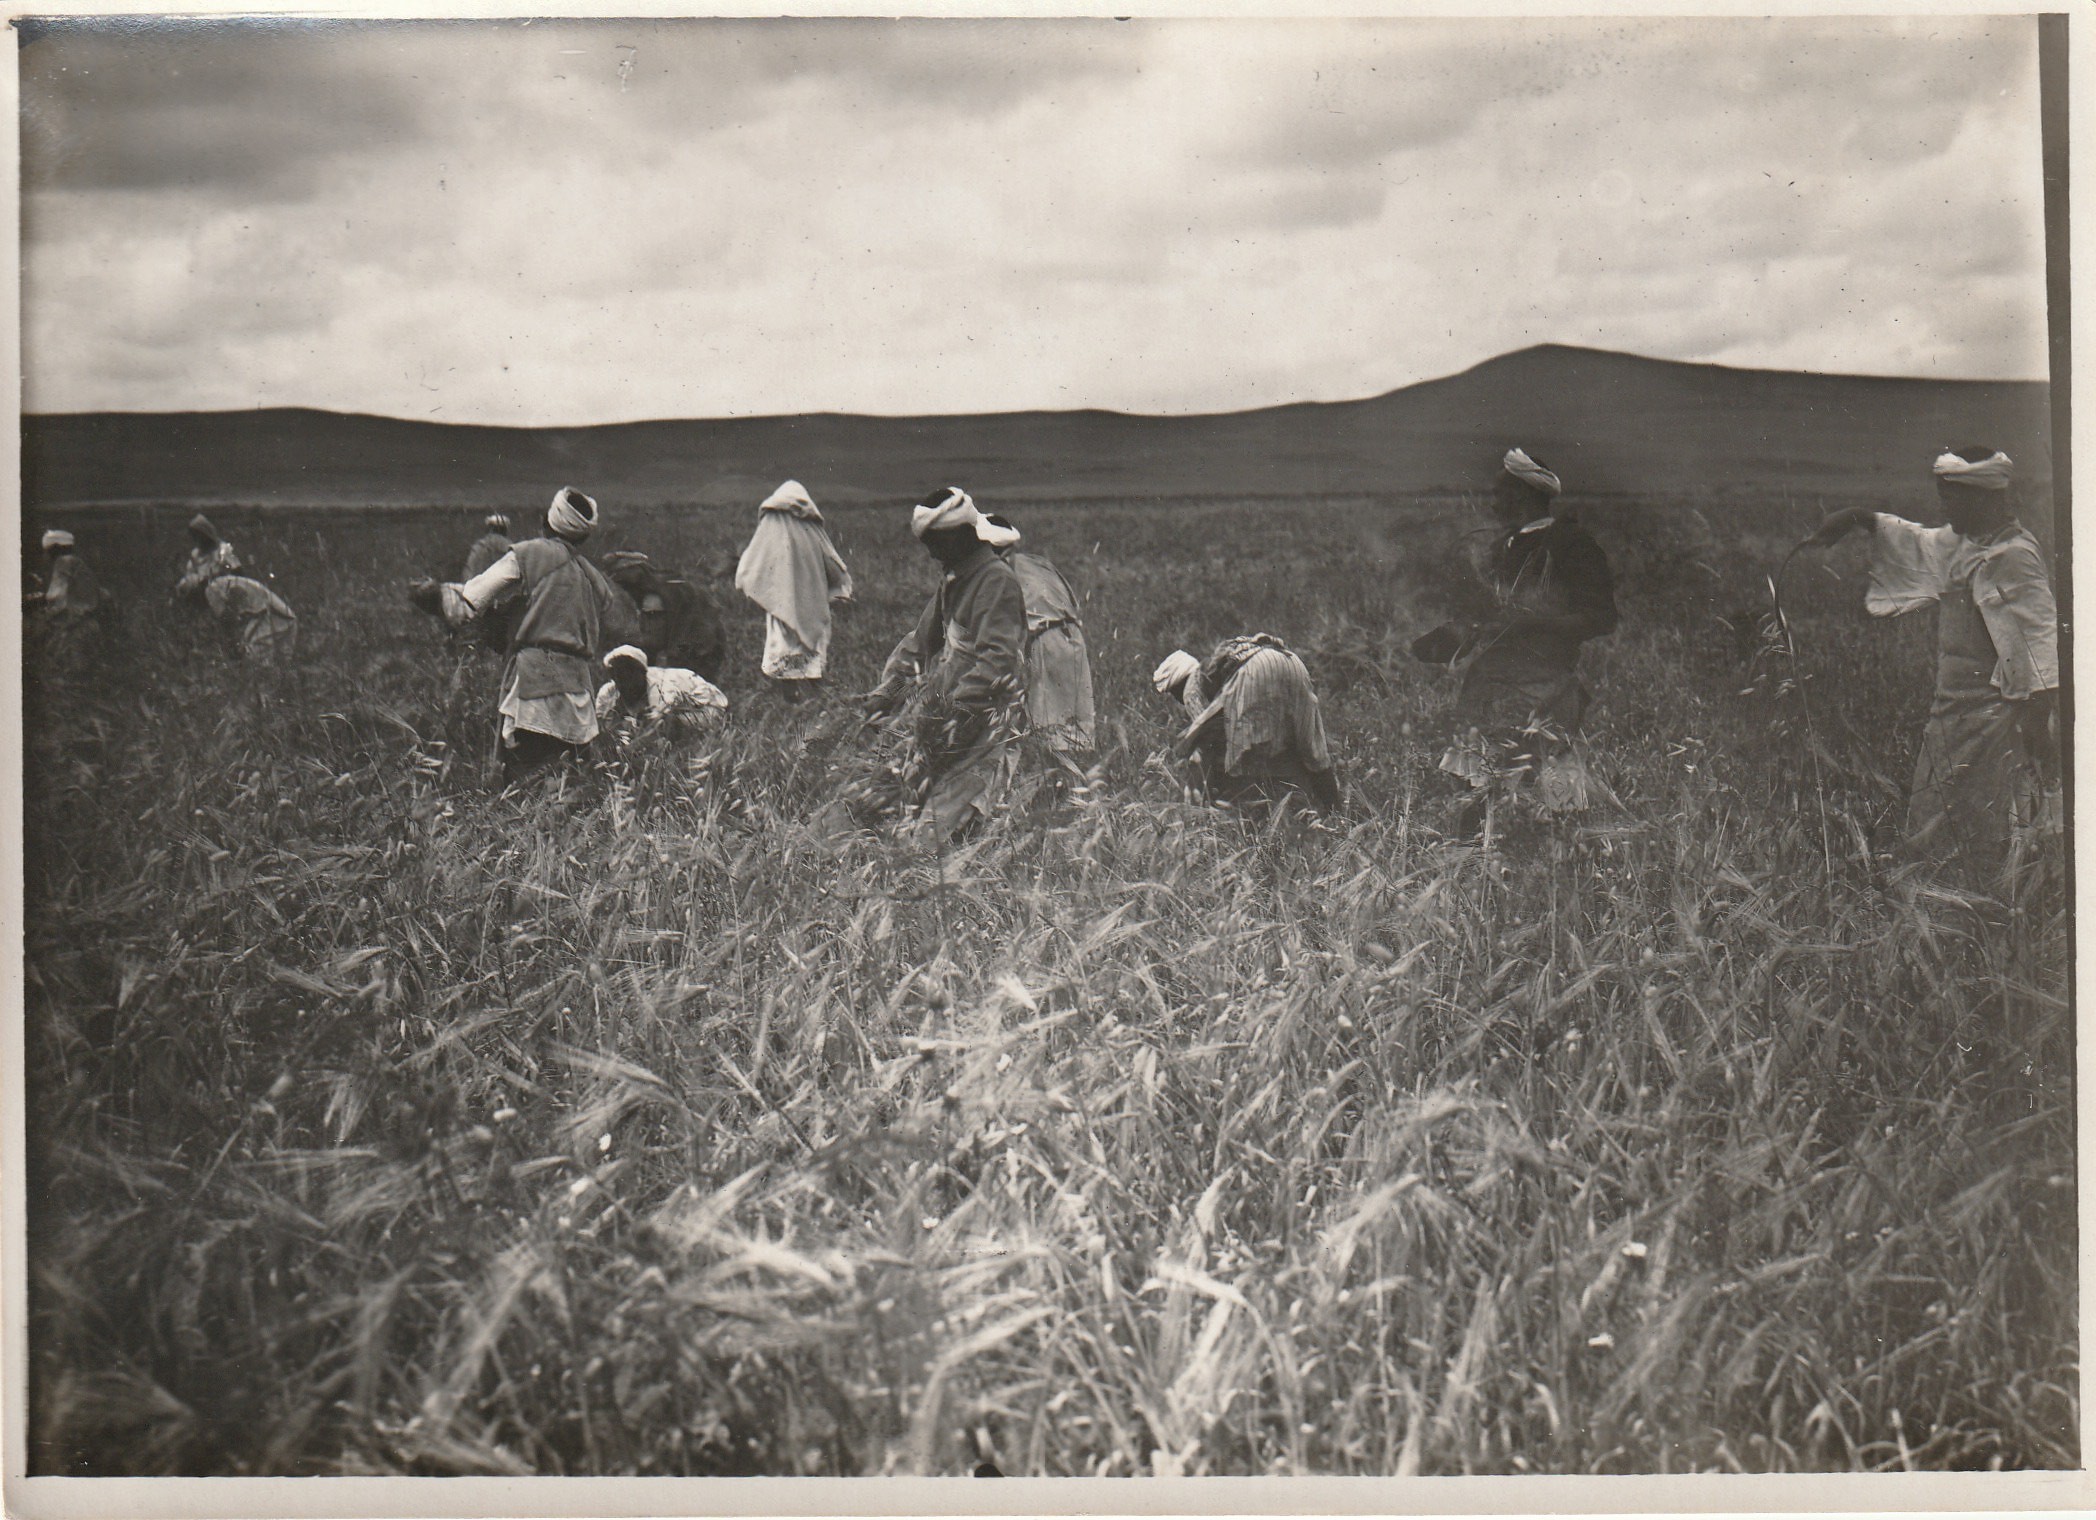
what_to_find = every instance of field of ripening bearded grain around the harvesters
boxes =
[25,494,2079,1476]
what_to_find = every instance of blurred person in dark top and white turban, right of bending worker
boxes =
[1413,449,1616,834]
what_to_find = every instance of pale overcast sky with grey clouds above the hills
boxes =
[21,17,2046,424]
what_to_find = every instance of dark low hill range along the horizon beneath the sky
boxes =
[23,344,2050,509]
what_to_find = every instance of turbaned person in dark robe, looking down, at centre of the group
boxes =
[866,486,1027,843]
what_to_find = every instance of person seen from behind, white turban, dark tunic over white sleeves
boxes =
[425,486,618,782]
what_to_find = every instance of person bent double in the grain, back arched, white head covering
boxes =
[1151,633,1339,813]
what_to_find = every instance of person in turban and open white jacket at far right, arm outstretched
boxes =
[1807,449,2060,891]
